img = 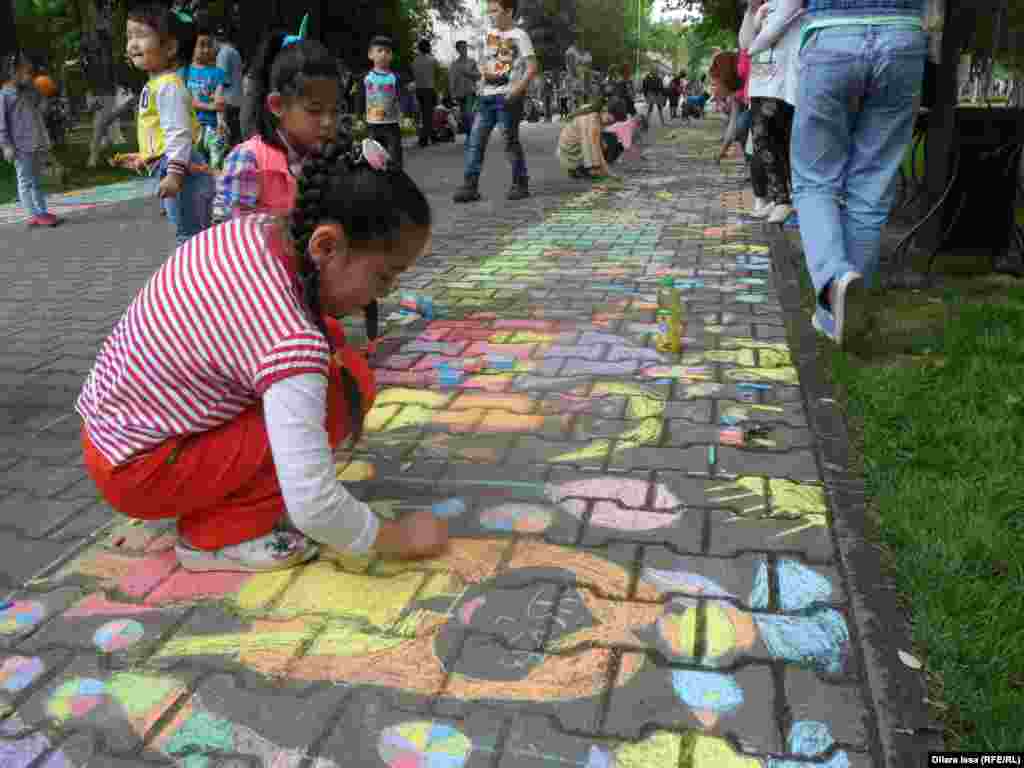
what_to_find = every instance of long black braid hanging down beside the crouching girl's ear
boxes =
[291,143,365,450]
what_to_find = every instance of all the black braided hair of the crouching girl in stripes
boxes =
[291,140,431,446]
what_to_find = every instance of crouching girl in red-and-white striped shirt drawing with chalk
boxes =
[77,141,447,571]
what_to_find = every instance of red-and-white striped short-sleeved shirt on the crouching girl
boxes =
[76,215,330,465]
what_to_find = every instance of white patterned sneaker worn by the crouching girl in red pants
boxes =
[174,530,318,573]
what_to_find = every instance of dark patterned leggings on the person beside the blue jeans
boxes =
[751,98,793,205]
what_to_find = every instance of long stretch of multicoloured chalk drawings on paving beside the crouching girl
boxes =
[0,129,866,768]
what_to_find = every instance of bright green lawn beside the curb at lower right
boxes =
[805,262,1024,751]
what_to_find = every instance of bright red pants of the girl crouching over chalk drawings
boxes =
[82,333,376,550]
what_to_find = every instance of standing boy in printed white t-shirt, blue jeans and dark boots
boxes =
[455,0,538,203]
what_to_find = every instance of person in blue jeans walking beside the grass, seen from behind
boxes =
[791,0,927,343]
